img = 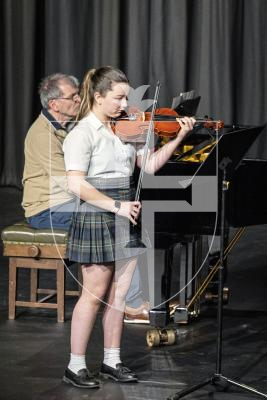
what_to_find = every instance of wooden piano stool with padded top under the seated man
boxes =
[1,221,81,322]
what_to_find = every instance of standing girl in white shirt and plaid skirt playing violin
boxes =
[63,66,195,388]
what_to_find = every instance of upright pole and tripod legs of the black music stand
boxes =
[167,157,267,400]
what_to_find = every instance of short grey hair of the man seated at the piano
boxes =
[39,73,79,108]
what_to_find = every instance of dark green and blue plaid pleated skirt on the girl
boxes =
[67,178,150,264]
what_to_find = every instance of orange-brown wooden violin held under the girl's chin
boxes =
[112,107,224,138]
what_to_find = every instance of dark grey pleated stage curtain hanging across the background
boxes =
[0,0,267,186]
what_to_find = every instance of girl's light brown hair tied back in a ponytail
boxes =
[77,66,129,120]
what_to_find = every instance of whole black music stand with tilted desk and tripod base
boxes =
[168,126,267,400]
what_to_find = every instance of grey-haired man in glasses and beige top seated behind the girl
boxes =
[22,73,148,322]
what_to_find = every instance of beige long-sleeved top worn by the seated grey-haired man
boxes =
[22,114,73,217]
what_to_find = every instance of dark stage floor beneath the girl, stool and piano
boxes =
[0,188,267,400]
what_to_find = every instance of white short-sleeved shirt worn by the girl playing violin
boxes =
[63,112,146,178]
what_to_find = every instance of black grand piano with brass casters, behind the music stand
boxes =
[141,126,267,327]
